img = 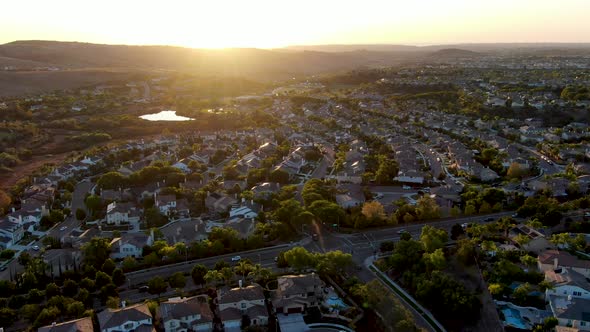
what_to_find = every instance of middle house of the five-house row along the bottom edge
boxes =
[160,295,213,332]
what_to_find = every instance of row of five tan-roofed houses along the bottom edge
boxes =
[39,273,325,332]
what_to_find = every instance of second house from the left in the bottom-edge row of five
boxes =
[97,302,155,332]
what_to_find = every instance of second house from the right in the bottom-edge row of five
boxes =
[217,280,268,331]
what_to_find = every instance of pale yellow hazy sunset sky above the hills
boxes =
[0,0,590,48]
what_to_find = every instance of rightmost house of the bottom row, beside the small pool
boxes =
[272,273,324,314]
